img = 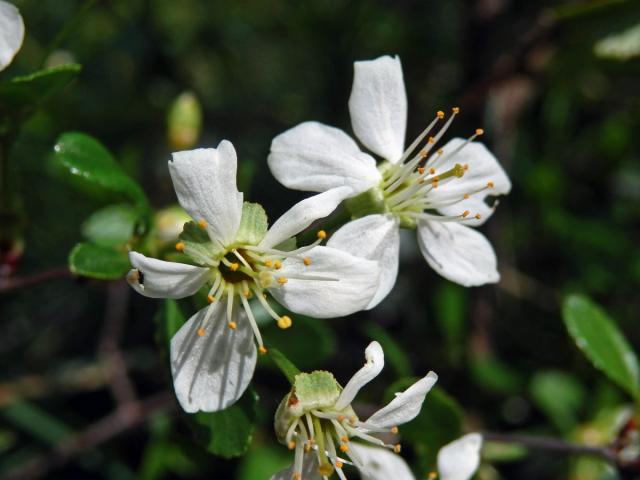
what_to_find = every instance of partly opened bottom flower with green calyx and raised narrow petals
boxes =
[273,342,438,480]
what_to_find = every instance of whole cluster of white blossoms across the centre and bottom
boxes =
[121,53,511,480]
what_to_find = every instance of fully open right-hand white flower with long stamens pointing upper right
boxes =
[268,56,511,308]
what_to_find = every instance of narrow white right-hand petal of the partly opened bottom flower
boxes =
[365,372,438,428]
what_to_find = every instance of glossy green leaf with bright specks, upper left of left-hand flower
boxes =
[52,132,148,207]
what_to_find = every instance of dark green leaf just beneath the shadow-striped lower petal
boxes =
[190,388,258,458]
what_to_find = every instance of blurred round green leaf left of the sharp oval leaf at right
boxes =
[530,370,587,433]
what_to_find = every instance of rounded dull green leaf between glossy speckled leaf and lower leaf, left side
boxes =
[82,204,139,247]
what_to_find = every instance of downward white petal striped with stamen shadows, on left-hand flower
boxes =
[171,302,256,413]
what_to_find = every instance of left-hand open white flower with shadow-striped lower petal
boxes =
[127,140,379,412]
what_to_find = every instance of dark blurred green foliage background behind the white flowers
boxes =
[0,0,640,480]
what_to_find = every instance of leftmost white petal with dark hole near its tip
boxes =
[127,252,209,298]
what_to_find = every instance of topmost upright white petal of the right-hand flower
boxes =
[349,56,407,163]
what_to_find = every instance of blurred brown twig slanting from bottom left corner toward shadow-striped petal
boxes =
[5,392,175,480]
